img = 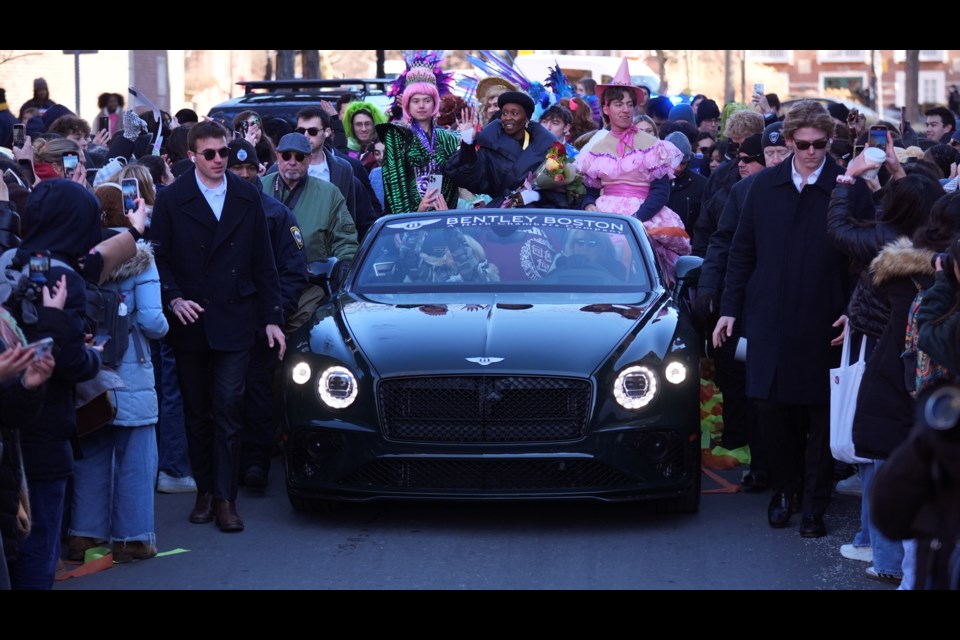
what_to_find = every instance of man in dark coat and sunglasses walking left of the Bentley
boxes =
[151,122,286,531]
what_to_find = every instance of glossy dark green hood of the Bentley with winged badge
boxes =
[343,294,657,376]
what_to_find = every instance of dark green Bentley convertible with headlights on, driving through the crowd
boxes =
[284,209,700,511]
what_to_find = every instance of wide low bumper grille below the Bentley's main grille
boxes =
[341,459,631,491]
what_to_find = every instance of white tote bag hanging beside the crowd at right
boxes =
[830,326,871,464]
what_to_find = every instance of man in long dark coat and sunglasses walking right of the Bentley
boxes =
[713,101,873,538]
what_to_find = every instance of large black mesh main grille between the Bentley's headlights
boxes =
[378,376,592,443]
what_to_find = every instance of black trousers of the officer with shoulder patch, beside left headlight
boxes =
[240,337,280,471]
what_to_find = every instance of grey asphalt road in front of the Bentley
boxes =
[54,461,893,590]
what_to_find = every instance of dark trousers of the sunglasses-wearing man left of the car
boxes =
[176,349,250,500]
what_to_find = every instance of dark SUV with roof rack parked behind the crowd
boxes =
[207,78,393,126]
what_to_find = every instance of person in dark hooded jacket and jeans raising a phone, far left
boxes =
[10,180,101,589]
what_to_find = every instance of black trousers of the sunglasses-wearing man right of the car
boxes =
[756,400,833,516]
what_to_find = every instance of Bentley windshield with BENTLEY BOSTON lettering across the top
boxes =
[353,211,656,293]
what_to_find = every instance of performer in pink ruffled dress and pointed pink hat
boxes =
[576,59,690,280]
